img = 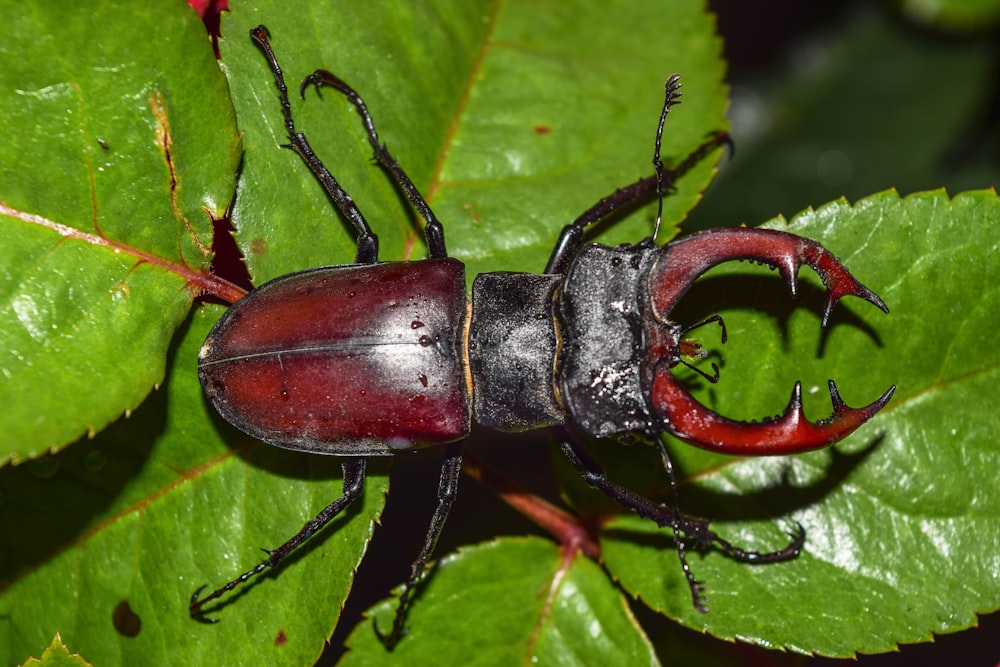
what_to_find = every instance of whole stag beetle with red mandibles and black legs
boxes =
[189,26,895,647]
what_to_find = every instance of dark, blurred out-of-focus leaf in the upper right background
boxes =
[684,3,1000,235]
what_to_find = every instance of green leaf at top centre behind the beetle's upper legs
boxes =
[222,2,726,282]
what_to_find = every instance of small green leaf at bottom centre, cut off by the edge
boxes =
[341,537,660,667]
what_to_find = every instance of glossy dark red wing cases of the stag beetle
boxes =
[198,259,471,456]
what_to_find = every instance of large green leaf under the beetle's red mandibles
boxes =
[603,191,1000,657]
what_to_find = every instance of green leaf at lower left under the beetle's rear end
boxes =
[0,307,387,665]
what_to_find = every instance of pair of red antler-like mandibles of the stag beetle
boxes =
[649,228,895,454]
